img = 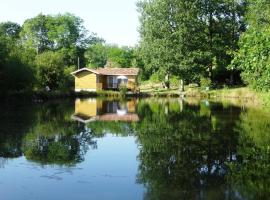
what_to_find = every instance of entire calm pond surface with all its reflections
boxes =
[0,99,270,200]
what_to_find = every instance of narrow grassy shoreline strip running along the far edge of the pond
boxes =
[0,87,270,107]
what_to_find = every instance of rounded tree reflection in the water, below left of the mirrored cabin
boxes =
[23,101,96,165]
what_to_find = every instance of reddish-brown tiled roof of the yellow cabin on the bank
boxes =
[71,68,139,76]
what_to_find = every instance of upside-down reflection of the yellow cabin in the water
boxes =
[72,99,139,123]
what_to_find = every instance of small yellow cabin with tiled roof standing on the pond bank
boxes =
[71,68,139,92]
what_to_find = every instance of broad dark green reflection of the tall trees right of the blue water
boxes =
[136,102,238,199]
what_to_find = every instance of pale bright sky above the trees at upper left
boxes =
[0,0,139,46]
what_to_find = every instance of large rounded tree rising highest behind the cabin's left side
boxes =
[20,13,93,66]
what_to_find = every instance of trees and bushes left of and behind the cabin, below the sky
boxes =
[0,13,142,94]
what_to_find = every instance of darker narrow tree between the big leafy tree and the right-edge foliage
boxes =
[199,0,246,82]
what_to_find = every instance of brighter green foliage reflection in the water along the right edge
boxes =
[230,109,270,199]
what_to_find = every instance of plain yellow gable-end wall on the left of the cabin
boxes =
[75,71,97,90]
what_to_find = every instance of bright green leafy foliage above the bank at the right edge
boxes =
[231,0,270,91]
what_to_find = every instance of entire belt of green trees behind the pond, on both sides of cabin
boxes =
[0,0,270,94]
